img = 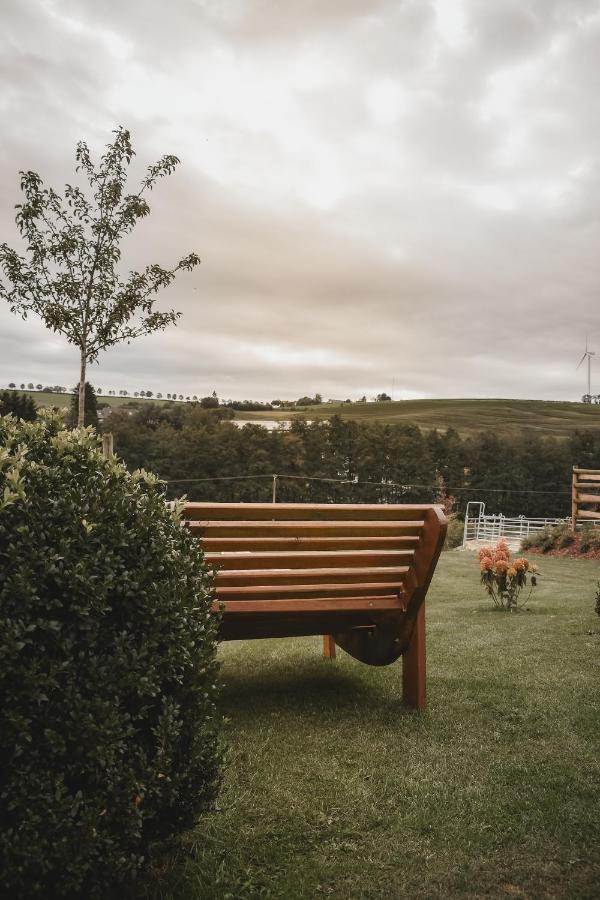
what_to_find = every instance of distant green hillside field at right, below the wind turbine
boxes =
[239,399,600,437]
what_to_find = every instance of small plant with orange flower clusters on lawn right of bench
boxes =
[479,541,539,611]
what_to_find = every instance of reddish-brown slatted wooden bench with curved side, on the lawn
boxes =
[183,503,446,709]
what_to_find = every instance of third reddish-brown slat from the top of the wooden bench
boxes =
[200,535,419,555]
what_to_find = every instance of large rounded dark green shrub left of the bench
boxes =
[0,415,220,898]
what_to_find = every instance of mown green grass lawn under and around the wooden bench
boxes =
[142,551,600,900]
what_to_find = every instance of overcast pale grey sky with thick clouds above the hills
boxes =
[0,0,600,400]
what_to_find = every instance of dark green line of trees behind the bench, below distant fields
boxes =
[102,404,600,517]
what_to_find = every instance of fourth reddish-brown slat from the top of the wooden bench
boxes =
[204,550,414,571]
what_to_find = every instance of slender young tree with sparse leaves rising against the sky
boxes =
[0,126,200,426]
